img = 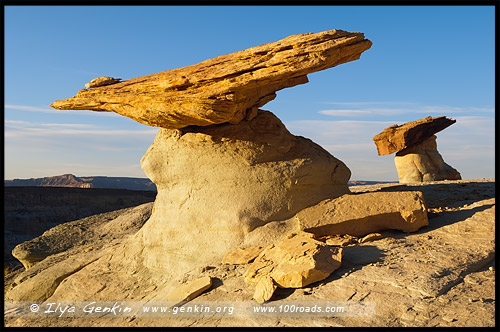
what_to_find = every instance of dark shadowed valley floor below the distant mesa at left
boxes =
[4,183,156,262]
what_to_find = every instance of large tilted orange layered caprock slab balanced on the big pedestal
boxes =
[51,30,372,129]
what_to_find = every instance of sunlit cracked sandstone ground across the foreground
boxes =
[5,179,496,327]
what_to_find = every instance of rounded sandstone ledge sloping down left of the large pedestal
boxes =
[6,203,153,301]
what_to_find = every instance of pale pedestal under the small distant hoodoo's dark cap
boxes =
[394,135,462,183]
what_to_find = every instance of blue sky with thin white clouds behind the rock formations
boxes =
[4,6,495,181]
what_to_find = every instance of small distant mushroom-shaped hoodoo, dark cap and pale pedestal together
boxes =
[373,116,462,183]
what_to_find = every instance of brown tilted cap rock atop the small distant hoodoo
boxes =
[373,116,456,156]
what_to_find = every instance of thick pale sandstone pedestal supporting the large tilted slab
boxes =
[137,111,350,272]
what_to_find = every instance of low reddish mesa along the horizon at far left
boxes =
[4,174,156,190]
